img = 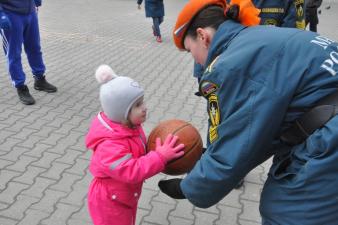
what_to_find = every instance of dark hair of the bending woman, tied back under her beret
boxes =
[183,5,239,40]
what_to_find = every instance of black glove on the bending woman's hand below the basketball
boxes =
[158,178,185,199]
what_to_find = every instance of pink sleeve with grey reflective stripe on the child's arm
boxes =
[94,141,165,184]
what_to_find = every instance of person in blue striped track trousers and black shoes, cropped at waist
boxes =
[0,0,57,105]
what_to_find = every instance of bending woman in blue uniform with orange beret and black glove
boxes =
[159,0,338,225]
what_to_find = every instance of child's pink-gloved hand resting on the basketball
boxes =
[155,134,184,162]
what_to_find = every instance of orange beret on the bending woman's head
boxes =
[173,0,260,50]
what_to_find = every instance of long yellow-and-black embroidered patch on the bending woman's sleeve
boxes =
[208,94,221,143]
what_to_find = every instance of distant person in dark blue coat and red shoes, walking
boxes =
[137,0,164,43]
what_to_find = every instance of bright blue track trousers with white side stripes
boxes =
[2,11,46,87]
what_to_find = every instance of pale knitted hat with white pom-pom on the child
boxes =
[95,65,144,123]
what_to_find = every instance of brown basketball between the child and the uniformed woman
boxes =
[147,119,203,175]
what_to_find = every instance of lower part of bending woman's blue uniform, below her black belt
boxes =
[260,116,338,225]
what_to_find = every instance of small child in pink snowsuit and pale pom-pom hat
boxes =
[86,65,184,225]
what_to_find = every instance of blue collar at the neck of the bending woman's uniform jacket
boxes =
[204,20,247,68]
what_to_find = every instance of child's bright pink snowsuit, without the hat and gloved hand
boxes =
[86,112,165,225]
